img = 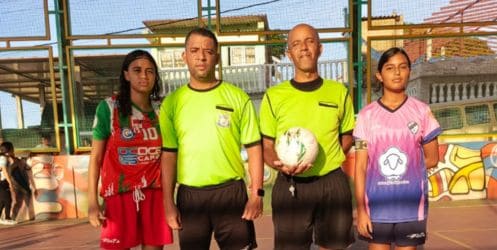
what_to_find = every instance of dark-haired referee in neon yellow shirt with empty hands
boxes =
[160,28,264,250]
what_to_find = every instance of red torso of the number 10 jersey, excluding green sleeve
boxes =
[97,97,161,197]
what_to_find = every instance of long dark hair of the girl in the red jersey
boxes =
[117,49,161,116]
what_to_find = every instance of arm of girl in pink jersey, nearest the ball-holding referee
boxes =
[354,141,373,239]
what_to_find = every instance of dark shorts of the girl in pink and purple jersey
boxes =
[359,220,426,247]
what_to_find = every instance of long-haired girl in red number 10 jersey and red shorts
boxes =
[88,50,172,249]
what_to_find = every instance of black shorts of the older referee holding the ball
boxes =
[272,168,354,249]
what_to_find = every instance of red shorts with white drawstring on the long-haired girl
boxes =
[100,189,173,249]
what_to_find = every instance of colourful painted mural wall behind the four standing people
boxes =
[13,142,497,219]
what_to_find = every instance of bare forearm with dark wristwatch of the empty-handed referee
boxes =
[242,143,264,220]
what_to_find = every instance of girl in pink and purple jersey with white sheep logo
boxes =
[353,48,441,250]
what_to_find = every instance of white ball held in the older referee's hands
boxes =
[275,127,318,167]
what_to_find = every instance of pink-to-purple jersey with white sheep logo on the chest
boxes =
[353,97,441,223]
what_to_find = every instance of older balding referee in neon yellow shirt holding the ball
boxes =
[260,24,354,250]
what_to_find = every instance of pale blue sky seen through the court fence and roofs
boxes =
[0,0,449,128]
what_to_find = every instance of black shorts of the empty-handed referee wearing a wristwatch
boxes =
[176,180,257,250]
